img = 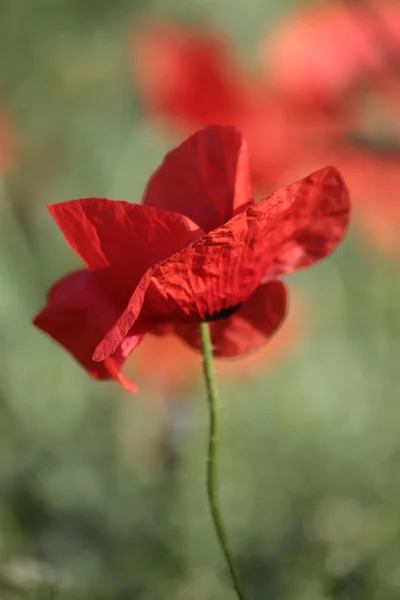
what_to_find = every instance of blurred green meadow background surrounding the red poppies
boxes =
[0,0,400,600]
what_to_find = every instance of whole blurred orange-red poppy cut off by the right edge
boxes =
[264,0,400,259]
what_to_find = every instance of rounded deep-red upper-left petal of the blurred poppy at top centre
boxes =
[131,22,250,131]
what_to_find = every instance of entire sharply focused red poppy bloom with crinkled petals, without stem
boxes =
[34,126,349,392]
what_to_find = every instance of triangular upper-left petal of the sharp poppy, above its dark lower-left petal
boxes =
[48,198,203,300]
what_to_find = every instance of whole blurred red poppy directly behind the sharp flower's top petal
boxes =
[131,22,354,190]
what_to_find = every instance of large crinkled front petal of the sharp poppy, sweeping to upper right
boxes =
[95,167,349,360]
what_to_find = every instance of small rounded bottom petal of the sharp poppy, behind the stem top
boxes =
[175,280,287,358]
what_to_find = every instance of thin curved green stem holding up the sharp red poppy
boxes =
[200,323,246,600]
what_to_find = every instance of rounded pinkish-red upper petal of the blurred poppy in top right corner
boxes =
[262,0,400,103]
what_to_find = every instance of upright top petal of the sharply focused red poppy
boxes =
[143,126,252,232]
